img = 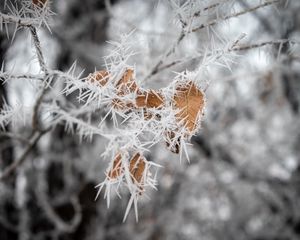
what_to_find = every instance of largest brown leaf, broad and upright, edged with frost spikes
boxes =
[173,81,205,133]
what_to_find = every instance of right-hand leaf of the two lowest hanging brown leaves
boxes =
[129,153,146,183]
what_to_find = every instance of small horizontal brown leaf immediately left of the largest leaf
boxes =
[135,89,164,108]
